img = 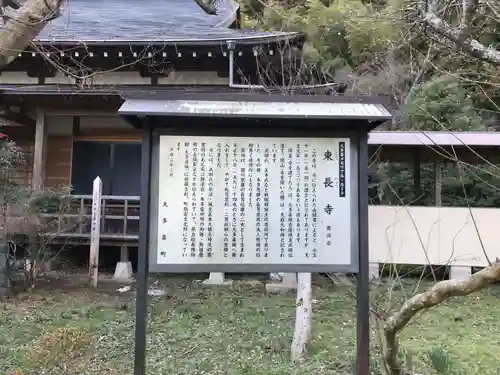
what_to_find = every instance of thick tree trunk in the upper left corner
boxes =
[0,0,62,68]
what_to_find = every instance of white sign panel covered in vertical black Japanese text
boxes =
[157,136,352,265]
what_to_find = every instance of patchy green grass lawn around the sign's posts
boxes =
[0,279,500,375]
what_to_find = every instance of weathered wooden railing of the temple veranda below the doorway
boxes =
[43,195,140,241]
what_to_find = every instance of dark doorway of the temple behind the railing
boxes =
[71,141,141,196]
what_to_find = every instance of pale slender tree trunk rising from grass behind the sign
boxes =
[292,272,312,362]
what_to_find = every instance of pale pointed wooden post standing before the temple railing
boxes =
[89,176,102,288]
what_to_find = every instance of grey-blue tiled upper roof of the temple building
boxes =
[35,0,297,44]
